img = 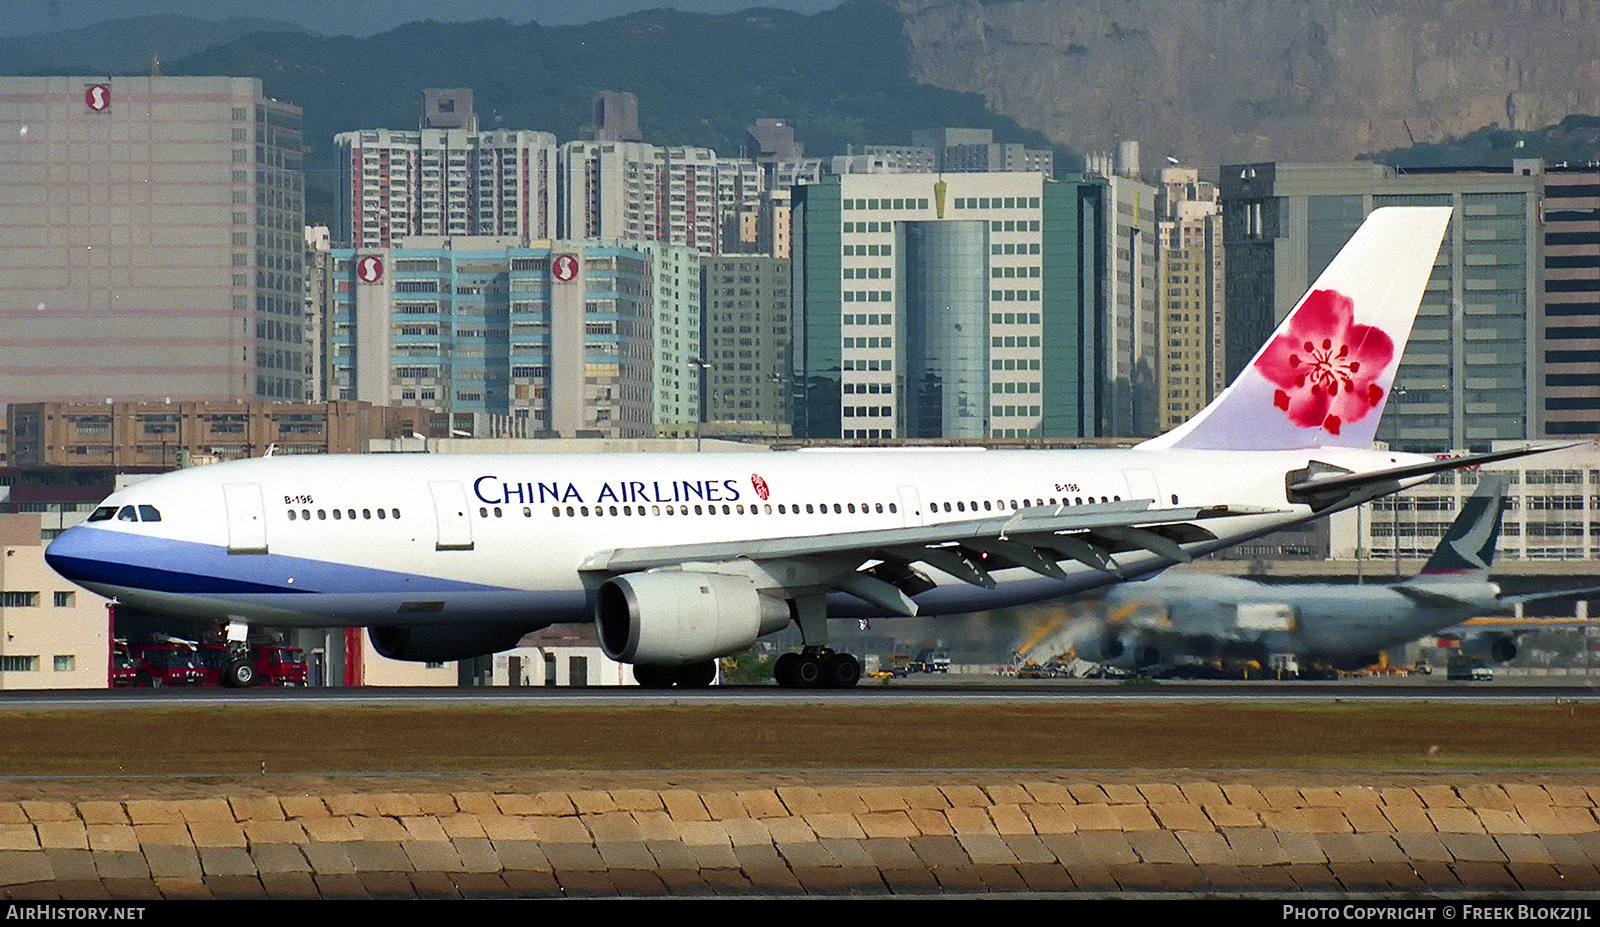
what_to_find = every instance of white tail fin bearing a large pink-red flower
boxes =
[1141,207,1450,450]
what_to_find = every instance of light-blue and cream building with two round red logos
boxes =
[328,237,654,437]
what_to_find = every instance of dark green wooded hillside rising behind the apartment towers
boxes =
[165,0,1078,193]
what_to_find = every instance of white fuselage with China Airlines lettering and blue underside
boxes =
[46,448,1426,628]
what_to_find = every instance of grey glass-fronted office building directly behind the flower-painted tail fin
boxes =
[1221,160,1544,451]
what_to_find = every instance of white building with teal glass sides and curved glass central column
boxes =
[792,173,1110,440]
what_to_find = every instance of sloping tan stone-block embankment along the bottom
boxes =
[0,772,1600,900]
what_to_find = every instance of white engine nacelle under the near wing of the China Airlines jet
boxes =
[595,570,789,666]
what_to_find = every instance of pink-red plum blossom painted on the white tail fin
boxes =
[1256,290,1395,434]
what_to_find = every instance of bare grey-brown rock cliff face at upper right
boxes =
[898,0,1600,168]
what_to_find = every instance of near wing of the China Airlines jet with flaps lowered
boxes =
[579,500,1278,616]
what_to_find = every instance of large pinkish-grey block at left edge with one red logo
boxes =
[0,77,306,402]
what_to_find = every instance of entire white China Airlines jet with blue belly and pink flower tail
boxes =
[46,208,1548,687]
